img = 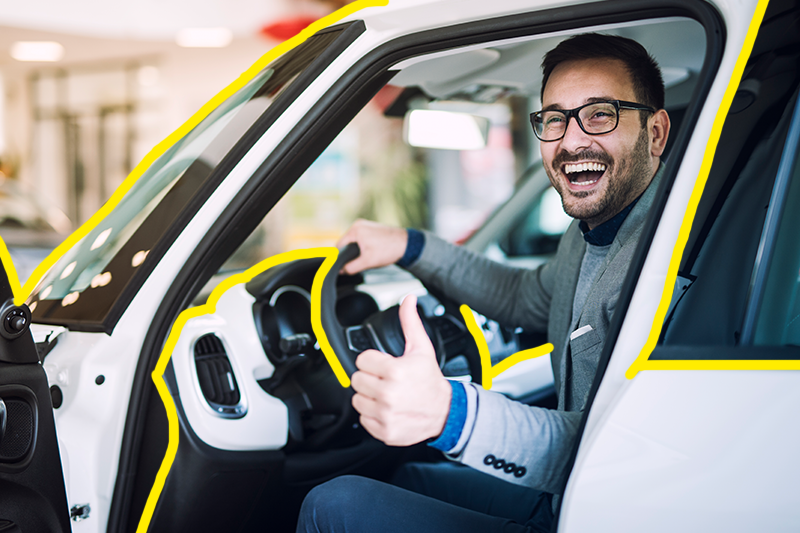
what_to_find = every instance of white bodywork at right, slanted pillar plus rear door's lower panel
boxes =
[560,2,800,531]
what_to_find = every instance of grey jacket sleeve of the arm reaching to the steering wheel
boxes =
[408,232,555,331]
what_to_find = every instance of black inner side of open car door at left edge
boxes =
[0,260,71,533]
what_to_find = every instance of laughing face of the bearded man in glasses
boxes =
[541,59,663,228]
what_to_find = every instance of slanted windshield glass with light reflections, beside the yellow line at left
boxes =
[27,29,354,331]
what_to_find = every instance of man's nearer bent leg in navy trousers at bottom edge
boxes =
[297,476,549,533]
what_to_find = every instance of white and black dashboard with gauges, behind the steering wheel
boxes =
[172,259,552,451]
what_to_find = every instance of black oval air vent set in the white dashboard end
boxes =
[194,334,245,418]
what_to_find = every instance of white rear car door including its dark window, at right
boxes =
[559,2,800,532]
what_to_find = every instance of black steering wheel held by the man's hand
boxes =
[320,243,481,384]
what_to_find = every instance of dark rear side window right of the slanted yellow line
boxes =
[652,2,800,359]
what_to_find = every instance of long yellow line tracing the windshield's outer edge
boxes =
[12,0,389,305]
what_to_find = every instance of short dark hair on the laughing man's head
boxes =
[542,33,664,122]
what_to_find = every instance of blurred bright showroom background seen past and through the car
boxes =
[0,0,538,283]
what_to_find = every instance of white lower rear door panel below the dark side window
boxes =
[559,347,800,533]
